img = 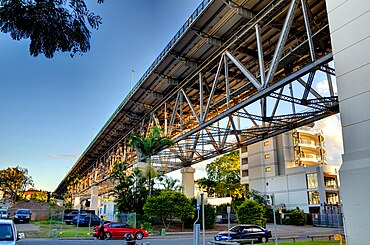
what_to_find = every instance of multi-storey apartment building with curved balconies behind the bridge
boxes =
[240,124,339,213]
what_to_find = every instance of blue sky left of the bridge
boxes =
[0,0,205,191]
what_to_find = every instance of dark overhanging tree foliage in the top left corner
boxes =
[0,0,104,58]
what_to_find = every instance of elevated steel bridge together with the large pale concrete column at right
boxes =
[52,0,370,242]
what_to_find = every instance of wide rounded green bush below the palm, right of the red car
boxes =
[144,191,194,229]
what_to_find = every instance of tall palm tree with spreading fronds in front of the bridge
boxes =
[129,127,174,196]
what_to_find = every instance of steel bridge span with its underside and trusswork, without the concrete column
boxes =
[56,0,338,196]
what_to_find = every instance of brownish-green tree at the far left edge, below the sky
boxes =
[0,166,33,203]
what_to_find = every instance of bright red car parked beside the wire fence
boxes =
[93,222,148,240]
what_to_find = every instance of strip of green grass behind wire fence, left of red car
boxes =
[21,221,94,238]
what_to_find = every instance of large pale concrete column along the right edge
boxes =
[326,0,370,245]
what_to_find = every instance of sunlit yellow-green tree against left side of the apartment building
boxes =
[197,151,244,198]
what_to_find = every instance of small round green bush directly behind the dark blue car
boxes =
[236,200,266,227]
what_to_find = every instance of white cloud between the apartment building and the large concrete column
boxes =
[315,114,343,166]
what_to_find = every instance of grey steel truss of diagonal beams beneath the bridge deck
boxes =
[60,0,338,195]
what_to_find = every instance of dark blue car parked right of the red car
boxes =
[215,225,272,243]
